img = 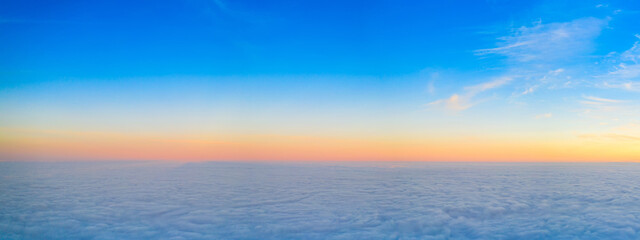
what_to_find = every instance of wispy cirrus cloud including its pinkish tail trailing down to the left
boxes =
[428,18,608,111]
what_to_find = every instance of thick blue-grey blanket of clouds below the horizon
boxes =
[0,162,640,239]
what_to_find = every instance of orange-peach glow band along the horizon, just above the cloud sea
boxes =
[0,126,640,162]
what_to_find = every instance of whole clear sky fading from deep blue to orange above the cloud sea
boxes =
[0,0,640,162]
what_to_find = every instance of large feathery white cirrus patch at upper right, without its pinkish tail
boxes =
[475,17,609,97]
